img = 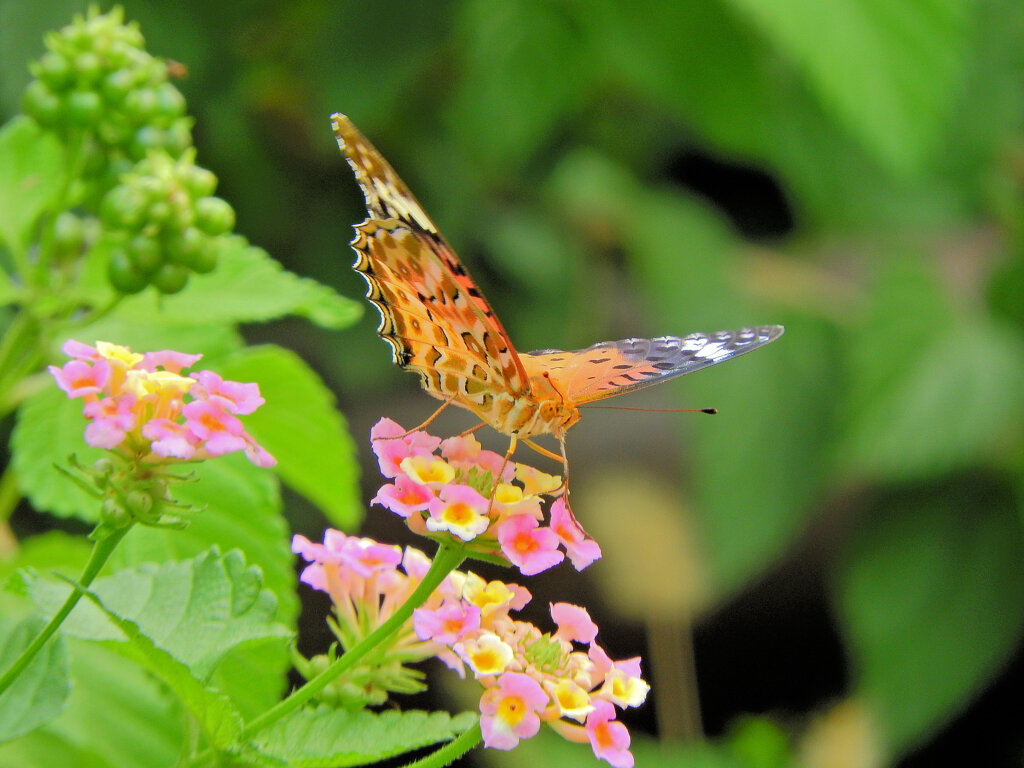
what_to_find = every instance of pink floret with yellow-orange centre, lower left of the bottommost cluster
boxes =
[480,672,548,750]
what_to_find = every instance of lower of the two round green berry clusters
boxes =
[99,150,234,294]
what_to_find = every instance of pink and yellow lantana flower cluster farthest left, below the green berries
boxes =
[49,340,276,467]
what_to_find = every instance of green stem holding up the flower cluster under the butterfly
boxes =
[243,544,466,736]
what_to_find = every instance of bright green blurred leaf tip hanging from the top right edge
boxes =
[729,0,971,171]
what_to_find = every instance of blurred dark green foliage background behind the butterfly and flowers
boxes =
[8,0,1024,767]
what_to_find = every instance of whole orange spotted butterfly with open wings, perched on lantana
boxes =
[331,114,783,470]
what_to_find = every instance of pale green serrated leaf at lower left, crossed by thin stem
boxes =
[32,550,289,680]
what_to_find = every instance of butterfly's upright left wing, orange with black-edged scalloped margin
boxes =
[332,115,529,409]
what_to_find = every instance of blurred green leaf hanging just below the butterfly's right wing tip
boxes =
[678,315,838,593]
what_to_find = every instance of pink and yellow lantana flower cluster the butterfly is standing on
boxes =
[370,419,601,575]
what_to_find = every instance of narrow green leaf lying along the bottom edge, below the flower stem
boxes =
[254,707,477,768]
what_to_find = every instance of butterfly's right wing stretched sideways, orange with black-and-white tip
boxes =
[521,326,782,406]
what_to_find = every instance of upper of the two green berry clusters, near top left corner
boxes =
[22,7,193,199]
